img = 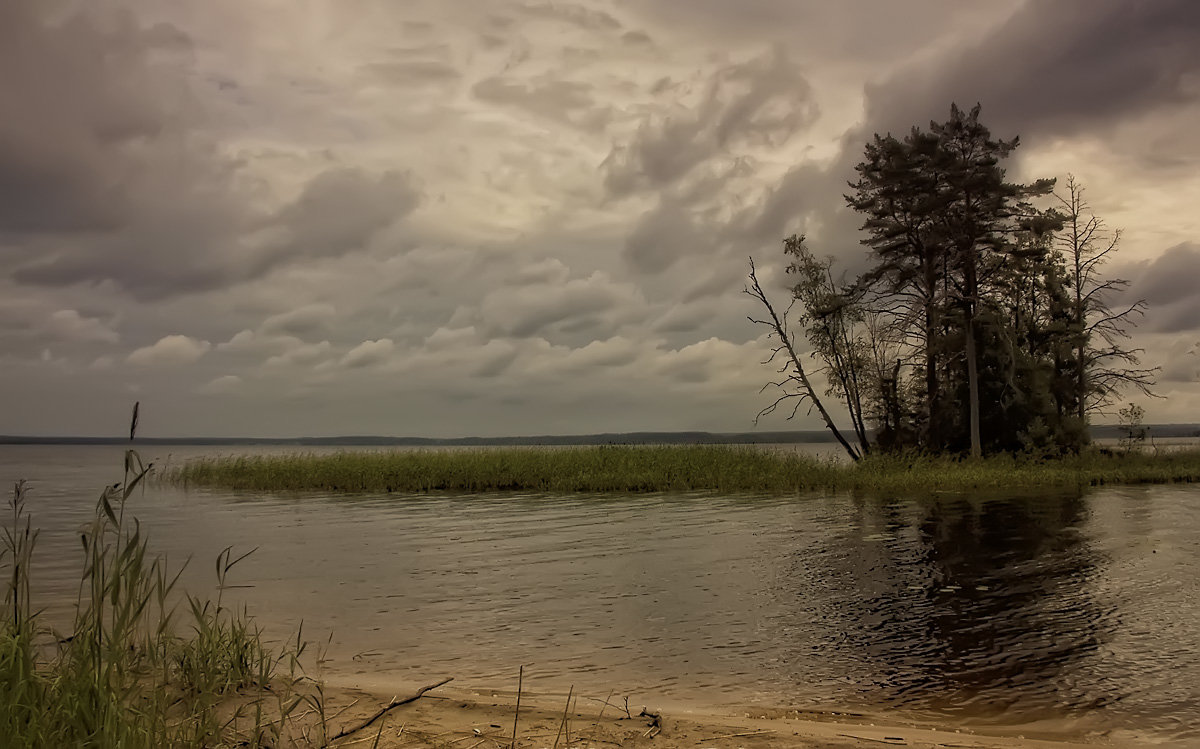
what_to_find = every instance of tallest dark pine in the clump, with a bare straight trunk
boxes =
[846,104,1054,455]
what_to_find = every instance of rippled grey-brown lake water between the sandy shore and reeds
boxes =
[0,445,1200,745]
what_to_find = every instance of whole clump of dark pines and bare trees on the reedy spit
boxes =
[746,104,1157,460]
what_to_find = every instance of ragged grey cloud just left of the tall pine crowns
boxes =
[602,48,817,282]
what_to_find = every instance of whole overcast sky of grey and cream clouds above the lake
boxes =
[0,0,1200,437]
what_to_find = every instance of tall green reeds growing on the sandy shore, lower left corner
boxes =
[0,450,319,749]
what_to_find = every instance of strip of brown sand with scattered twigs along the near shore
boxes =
[304,682,1108,749]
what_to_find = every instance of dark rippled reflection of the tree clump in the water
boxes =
[797,496,1116,719]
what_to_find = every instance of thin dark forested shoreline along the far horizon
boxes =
[0,424,1200,447]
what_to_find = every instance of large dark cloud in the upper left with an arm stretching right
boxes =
[0,1,430,299]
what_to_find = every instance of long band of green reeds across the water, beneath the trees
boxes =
[163,445,1200,493]
